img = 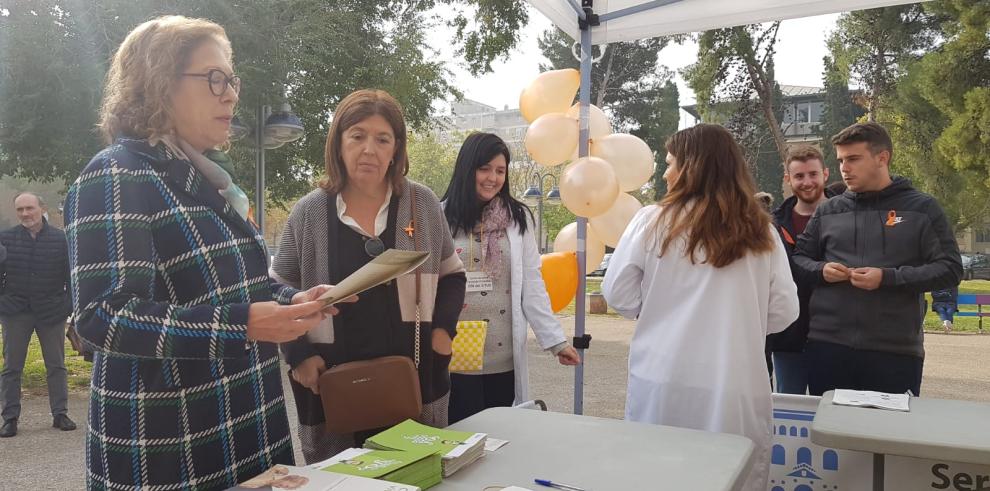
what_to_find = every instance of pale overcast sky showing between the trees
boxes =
[429,8,838,126]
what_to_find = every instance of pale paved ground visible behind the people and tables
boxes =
[0,316,990,491]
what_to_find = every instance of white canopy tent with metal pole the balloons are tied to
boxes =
[527,0,914,414]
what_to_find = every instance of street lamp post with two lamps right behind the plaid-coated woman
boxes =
[230,103,305,236]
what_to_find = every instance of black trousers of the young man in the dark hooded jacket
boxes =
[804,340,925,396]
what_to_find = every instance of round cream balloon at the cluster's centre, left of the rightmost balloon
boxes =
[560,157,619,218]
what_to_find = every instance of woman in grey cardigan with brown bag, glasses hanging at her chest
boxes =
[272,90,466,463]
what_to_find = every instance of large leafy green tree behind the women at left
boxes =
[0,0,527,201]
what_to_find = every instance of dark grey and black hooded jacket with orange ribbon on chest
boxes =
[792,177,962,357]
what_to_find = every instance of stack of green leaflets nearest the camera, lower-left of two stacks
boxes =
[317,448,442,489]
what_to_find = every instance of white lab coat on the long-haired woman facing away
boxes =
[602,205,799,491]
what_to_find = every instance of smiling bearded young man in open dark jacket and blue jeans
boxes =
[767,145,833,394]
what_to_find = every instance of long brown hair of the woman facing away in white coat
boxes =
[653,124,774,268]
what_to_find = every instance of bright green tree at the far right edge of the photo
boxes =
[890,0,990,228]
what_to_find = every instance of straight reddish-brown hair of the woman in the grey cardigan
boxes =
[320,89,409,195]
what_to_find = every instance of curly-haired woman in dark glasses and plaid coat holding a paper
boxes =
[65,16,334,489]
